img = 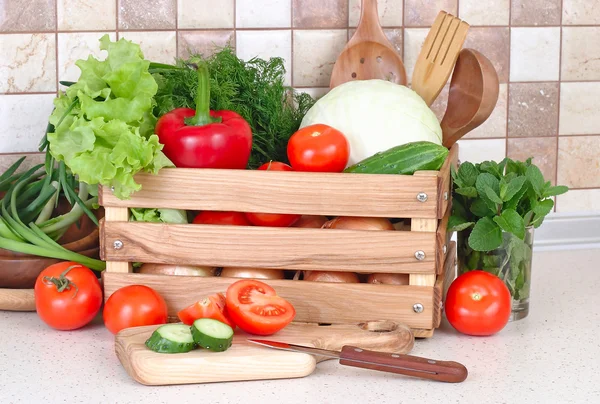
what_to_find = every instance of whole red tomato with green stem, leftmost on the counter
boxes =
[34,261,102,330]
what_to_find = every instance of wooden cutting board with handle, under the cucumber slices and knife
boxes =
[115,321,414,385]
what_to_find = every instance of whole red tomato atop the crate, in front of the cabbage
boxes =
[287,124,350,173]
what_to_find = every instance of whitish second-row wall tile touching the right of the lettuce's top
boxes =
[119,31,177,64]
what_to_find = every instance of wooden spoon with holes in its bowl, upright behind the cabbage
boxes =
[329,0,406,88]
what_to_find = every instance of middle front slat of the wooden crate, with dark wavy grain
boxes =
[103,219,437,274]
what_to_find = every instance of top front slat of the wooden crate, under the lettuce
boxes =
[100,168,439,218]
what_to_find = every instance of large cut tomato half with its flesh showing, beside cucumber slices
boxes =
[226,279,296,335]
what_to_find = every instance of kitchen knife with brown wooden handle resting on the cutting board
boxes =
[248,339,468,383]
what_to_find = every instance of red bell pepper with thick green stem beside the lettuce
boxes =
[155,63,252,169]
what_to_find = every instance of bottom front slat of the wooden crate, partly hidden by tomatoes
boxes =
[103,272,432,329]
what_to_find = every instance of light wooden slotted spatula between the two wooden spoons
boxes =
[411,11,469,105]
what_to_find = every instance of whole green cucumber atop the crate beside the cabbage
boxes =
[344,141,449,175]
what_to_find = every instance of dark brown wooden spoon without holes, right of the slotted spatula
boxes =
[440,49,500,148]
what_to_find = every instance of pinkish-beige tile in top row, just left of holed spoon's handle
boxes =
[292,0,348,28]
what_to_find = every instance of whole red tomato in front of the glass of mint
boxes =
[444,271,512,335]
